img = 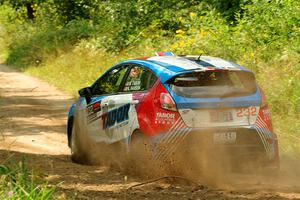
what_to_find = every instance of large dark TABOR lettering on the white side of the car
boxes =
[101,103,130,129]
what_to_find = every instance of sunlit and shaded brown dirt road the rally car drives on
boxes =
[0,65,300,200]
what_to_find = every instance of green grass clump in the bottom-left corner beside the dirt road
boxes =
[0,160,55,200]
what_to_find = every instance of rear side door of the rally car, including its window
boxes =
[108,64,157,142]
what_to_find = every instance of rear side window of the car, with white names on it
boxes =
[123,65,157,92]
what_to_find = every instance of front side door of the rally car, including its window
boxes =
[86,65,128,143]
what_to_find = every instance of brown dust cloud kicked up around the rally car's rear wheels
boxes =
[78,127,300,195]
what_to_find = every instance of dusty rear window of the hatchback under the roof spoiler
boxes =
[168,70,257,98]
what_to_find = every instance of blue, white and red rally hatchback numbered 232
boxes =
[67,52,279,168]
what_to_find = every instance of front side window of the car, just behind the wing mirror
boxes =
[92,66,128,95]
